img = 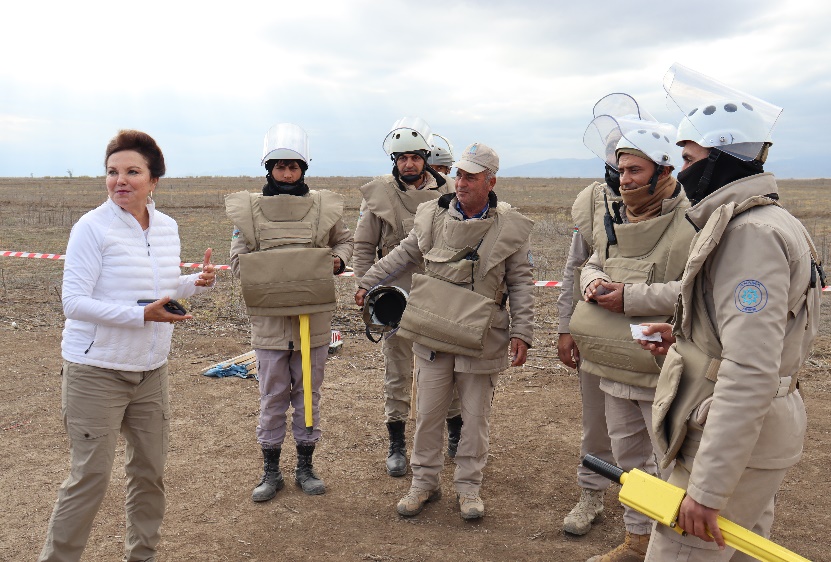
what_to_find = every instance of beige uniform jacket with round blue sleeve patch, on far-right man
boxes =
[682,173,820,509]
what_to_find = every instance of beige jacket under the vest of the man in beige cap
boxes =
[359,197,534,373]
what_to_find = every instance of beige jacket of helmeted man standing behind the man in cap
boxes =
[352,173,454,291]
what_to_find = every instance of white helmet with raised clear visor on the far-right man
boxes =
[664,63,782,161]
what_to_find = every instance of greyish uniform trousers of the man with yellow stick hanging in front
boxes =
[254,345,329,449]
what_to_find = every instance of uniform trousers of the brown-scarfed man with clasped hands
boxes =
[606,393,660,535]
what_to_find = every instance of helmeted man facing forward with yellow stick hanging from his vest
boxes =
[225,123,353,502]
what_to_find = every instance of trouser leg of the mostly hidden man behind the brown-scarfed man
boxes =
[577,365,614,490]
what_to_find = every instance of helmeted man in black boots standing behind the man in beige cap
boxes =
[352,117,462,477]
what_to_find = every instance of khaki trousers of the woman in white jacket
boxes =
[38,361,170,562]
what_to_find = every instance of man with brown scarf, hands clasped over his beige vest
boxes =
[570,110,694,562]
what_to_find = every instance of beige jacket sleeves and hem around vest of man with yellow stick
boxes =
[230,192,353,350]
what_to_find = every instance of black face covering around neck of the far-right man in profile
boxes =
[678,148,765,205]
